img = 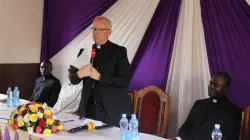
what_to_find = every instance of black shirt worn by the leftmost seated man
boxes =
[29,75,61,107]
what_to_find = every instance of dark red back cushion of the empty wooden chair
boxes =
[139,91,160,134]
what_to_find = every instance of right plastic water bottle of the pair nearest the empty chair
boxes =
[129,114,139,140]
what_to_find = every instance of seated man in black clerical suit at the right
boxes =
[173,72,241,140]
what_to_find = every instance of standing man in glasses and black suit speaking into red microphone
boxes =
[69,16,132,126]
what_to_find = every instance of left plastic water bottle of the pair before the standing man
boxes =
[120,114,128,140]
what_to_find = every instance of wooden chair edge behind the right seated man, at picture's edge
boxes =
[240,106,250,140]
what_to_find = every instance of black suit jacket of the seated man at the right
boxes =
[178,97,241,140]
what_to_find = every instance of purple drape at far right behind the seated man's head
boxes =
[200,0,250,107]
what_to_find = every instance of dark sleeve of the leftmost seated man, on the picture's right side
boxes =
[47,81,61,107]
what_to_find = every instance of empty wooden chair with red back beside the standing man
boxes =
[133,86,170,137]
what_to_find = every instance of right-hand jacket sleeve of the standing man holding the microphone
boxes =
[100,47,129,88]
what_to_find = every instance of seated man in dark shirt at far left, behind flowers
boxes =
[29,61,61,107]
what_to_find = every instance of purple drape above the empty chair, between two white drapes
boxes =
[129,0,181,91]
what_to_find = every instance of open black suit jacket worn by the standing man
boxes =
[69,41,132,126]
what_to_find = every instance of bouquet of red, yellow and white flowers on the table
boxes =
[8,102,63,135]
